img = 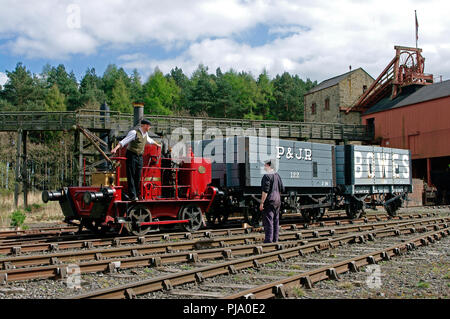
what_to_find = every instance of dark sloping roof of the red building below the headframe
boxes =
[364,80,450,114]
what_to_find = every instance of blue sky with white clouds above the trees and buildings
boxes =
[0,0,450,84]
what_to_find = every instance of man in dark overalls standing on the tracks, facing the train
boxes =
[259,160,284,243]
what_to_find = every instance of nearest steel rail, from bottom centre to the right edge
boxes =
[223,229,450,299]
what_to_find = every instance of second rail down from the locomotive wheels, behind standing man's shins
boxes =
[0,217,444,270]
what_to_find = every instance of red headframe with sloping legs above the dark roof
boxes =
[346,46,433,113]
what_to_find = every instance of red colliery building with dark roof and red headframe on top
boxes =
[353,46,450,204]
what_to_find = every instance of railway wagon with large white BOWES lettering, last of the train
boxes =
[335,145,412,218]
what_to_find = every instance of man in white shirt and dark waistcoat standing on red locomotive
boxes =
[111,119,161,201]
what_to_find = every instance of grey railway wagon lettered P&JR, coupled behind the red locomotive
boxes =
[191,136,336,224]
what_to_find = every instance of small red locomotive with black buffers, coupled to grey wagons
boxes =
[42,145,217,236]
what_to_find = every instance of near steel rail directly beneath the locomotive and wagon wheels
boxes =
[0,214,432,255]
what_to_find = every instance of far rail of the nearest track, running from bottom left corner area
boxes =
[66,220,448,299]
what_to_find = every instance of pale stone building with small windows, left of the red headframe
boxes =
[304,68,374,125]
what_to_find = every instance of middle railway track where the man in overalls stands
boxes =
[0,217,444,283]
